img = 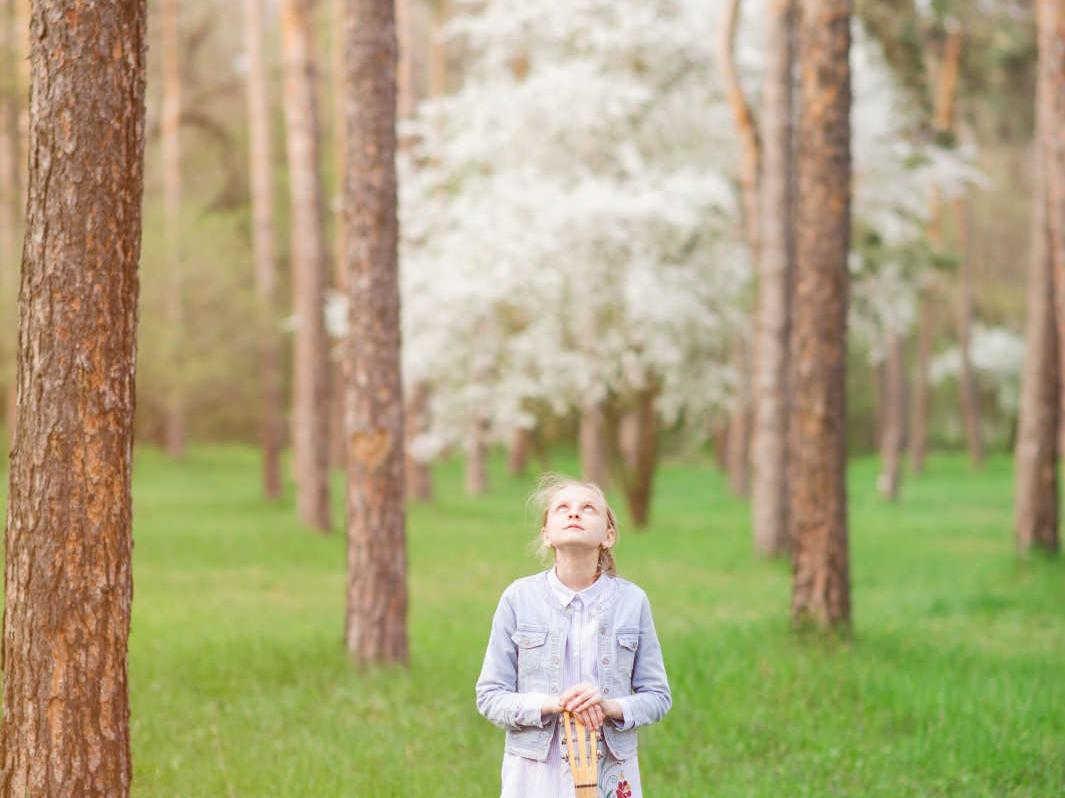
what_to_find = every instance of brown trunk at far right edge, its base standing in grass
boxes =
[1014,0,1065,552]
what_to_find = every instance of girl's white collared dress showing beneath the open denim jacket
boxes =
[501,568,643,798]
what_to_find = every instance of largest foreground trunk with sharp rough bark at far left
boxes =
[0,0,147,798]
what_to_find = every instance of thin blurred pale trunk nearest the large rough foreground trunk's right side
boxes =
[160,0,185,457]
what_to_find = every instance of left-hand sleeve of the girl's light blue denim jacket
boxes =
[476,591,550,730]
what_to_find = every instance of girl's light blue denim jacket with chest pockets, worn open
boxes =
[476,569,673,762]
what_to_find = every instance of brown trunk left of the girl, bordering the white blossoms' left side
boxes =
[344,0,409,664]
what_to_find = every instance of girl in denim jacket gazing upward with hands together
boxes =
[476,475,673,798]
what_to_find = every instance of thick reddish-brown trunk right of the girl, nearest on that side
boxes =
[790,0,851,626]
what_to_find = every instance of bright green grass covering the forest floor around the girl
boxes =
[29,446,1065,798]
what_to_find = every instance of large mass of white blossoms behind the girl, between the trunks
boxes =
[399,0,750,457]
